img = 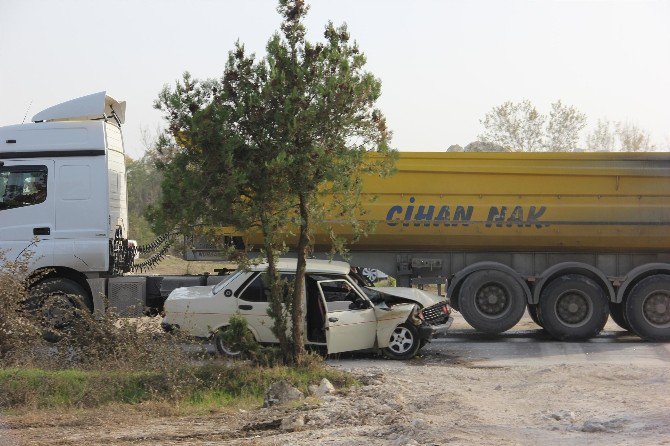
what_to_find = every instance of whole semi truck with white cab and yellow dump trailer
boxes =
[0,92,670,341]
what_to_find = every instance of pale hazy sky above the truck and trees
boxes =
[0,0,670,157]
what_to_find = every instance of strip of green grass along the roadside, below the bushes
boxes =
[0,364,356,411]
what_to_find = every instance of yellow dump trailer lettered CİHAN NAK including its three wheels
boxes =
[247,152,670,340]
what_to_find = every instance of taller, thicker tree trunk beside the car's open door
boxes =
[292,194,309,364]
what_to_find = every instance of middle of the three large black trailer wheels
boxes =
[540,274,609,341]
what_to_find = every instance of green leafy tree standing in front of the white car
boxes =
[151,0,395,361]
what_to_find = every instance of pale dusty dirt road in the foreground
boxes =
[0,319,670,446]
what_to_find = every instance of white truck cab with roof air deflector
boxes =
[0,92,128,308]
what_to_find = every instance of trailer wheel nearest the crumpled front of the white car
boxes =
[458,270,526,334]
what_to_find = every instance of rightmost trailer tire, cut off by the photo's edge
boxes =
[626,274,670,342]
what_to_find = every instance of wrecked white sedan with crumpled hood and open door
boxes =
[163,259,452,359]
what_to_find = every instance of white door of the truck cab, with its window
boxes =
[0,159,56,269]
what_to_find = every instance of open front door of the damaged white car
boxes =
[317,279,377,353]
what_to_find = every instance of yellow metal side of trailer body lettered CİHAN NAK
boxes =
[248,152,670,252]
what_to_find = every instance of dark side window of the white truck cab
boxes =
[0,166,47,210]
